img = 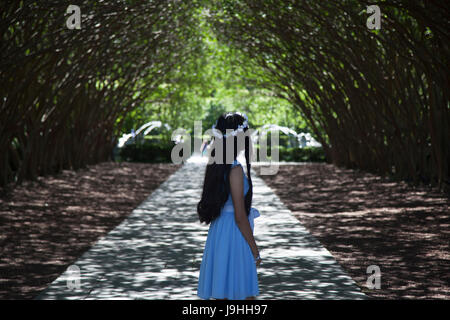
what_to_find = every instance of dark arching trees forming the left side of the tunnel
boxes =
[0,0,203,187]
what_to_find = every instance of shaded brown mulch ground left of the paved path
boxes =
[0,162,180,299]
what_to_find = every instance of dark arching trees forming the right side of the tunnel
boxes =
[209,0,450,190]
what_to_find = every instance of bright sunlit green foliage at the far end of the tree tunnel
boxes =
[118,5,307,141]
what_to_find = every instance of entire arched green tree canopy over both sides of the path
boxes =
[0,0,450,192]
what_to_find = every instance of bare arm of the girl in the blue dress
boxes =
[230,166,259,259]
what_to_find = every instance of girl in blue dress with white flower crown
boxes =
[197,112,261,300]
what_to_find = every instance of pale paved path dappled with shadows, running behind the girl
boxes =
[37,157,366,299]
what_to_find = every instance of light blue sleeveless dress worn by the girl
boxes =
[197,160,259,300]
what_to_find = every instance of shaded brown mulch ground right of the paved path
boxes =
[255,163,450,299]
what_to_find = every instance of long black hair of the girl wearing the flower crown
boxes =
[197,112,253,224]
